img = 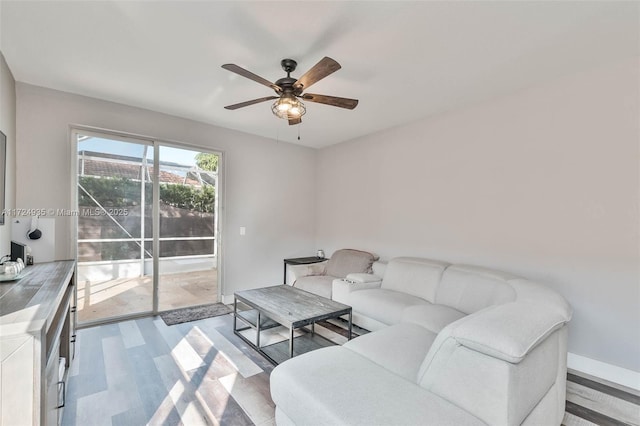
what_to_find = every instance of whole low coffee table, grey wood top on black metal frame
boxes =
[233,285,352,364]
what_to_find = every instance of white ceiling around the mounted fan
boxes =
[0,0,640,147]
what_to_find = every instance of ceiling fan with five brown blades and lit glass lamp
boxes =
[222,56,358,125]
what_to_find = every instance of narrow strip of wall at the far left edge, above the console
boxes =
[0,52,16,256]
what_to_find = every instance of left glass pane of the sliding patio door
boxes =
[77,134,154,323]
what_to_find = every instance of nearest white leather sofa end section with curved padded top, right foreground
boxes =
[417,302,570,424]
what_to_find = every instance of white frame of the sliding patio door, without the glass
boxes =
[69,125,225,328]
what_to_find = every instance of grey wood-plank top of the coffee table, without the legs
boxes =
[235,285,351,328]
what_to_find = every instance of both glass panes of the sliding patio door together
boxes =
[74,130,219,324]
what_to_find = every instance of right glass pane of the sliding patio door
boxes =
[158,145,218,311]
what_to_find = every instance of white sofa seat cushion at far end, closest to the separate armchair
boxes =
[349,288,429,325]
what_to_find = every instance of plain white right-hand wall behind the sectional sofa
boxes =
[316,61,640,372]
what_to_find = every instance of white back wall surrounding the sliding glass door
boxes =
[16,83,315,296]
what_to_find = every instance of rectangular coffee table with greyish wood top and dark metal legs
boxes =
[233,285,352,364]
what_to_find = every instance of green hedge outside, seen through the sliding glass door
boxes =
[78,175,217,213]
